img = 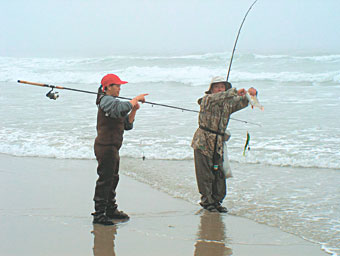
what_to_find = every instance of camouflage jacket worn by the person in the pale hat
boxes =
[191,88,248,158]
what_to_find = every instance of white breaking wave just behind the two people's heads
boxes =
[0,66,340,86]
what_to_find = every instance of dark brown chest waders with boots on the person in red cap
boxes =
[92,95,132,225]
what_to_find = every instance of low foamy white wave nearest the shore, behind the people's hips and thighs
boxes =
[0,136,340,169]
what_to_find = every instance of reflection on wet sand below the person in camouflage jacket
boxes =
[194,210,233,256]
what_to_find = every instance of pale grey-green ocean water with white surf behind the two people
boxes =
[0,53,340,255]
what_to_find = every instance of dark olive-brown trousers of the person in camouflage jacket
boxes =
[194,149,227,208]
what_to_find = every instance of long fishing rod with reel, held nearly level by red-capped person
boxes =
[18,80,261,126]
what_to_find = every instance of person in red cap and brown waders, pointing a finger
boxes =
[92,74,148,225]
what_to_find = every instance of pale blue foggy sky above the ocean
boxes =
[0,0,340,57]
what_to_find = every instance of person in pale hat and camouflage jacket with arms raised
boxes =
[191,77,257,212]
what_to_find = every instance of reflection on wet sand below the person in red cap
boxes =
[92,224,117,256]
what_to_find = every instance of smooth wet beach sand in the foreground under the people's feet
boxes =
[0,155,328,256]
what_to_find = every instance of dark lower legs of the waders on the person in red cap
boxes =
[93,144,120,214]
